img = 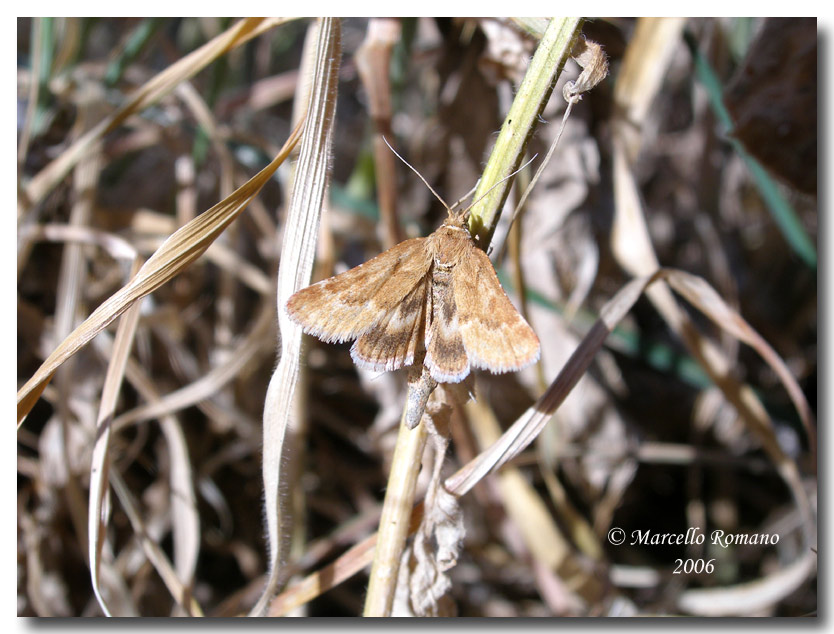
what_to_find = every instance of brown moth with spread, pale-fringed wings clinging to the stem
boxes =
[287,206,539,386]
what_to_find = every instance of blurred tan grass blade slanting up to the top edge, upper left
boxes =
[21,18,284,207]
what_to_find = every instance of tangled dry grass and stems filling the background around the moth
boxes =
[17,18,817,616]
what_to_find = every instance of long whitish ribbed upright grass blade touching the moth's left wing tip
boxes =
[252,18,341,615]
